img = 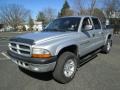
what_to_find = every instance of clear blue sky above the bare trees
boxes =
[0,0,102,19]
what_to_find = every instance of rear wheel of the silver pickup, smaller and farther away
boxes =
[102,39,112,54]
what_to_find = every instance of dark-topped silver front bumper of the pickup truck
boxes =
[7,51,57,72]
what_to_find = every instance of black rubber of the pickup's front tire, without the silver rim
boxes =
[53,52,77,83]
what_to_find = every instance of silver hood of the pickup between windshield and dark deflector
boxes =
[17,32,73,42]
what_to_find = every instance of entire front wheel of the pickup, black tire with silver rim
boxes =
[53,52,77,83]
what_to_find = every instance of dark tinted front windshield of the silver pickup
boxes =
[44,17,80,32]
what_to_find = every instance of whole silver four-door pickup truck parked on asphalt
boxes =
[8,16,113,83]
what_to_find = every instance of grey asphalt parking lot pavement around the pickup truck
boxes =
[0,33,120,90]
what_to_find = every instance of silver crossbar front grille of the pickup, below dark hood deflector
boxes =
[9,42,31,56]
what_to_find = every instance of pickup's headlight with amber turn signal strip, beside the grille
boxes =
[32,48,51,58]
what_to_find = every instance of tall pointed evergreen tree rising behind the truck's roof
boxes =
[59,0,73,17]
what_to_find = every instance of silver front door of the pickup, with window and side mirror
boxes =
[79,17,95,56]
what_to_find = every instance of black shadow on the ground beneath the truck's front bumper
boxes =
[19,67,53,81]
